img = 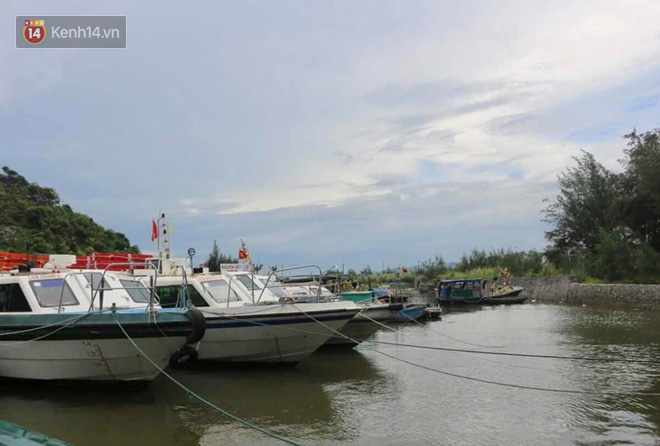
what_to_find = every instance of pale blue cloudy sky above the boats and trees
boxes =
[0,0,660,270]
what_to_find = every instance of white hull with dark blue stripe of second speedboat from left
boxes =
[197,302,359,364]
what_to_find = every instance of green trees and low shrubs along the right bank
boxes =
[349,129,660,285]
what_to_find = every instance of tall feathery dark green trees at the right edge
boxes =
[545,129,660,283]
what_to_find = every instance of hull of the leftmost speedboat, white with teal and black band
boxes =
[0,311,199,382]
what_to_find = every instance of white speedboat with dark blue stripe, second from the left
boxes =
[151,272,360,363]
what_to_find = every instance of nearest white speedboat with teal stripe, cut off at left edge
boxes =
[0,256,205,382]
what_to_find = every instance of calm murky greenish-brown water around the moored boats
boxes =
[0,304,660,445]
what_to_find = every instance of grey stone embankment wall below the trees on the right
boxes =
[511,276,660,310]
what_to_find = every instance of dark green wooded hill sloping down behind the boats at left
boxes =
[0,167,139,255]
